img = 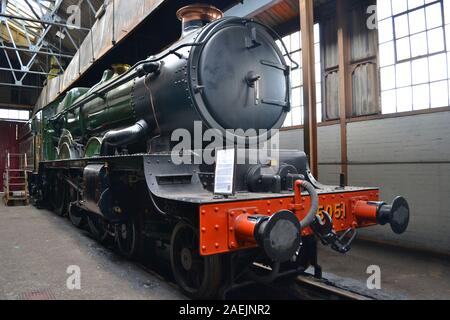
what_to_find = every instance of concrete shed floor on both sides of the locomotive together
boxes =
[0,204,450,299]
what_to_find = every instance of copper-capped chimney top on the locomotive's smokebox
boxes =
[177,3,223,34]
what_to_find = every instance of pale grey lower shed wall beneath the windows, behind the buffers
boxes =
[280,111,450,254]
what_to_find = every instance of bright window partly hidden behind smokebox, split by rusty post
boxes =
[278,23,322,127]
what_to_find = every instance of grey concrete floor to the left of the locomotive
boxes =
[0,201,184,300]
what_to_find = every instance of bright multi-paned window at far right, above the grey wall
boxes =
[377,0,450,114]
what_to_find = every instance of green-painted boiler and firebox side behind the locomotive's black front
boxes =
[37,70,137,161]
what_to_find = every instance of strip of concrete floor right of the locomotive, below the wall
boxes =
[319,241,450,300]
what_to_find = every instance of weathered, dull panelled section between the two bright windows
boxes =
[320,0,381,121]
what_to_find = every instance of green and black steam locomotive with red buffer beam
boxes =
[22,5,409,299]
